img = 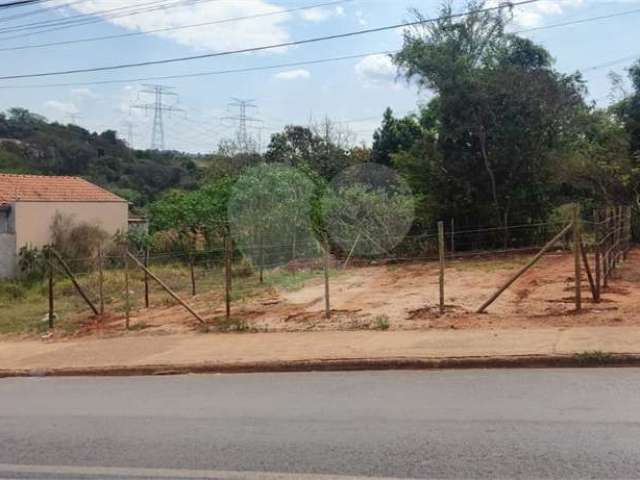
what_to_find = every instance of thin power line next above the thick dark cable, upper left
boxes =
[0,0,355,52]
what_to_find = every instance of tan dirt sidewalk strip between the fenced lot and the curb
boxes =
[0,327,640,376]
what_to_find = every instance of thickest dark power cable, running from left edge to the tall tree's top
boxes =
[0,0,540,80]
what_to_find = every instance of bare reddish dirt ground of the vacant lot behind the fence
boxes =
[95,249,640,333]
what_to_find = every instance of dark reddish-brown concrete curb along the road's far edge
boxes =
[0,353,640,378]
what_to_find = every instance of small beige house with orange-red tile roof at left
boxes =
[0,173,129,278]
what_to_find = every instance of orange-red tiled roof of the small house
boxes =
[0,173,126,204]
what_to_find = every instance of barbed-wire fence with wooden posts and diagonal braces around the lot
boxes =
[3,207,631,334]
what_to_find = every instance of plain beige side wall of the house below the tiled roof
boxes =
[14,202,129,250]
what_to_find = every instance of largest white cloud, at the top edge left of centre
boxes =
[60,0,291,51]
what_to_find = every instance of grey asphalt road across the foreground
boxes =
[0,368,640,480]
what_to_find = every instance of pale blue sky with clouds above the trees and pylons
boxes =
[0,0,640,153]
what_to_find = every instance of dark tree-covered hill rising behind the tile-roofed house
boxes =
[0,108,200,206]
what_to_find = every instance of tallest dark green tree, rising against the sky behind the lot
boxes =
[393,1,584,232]
